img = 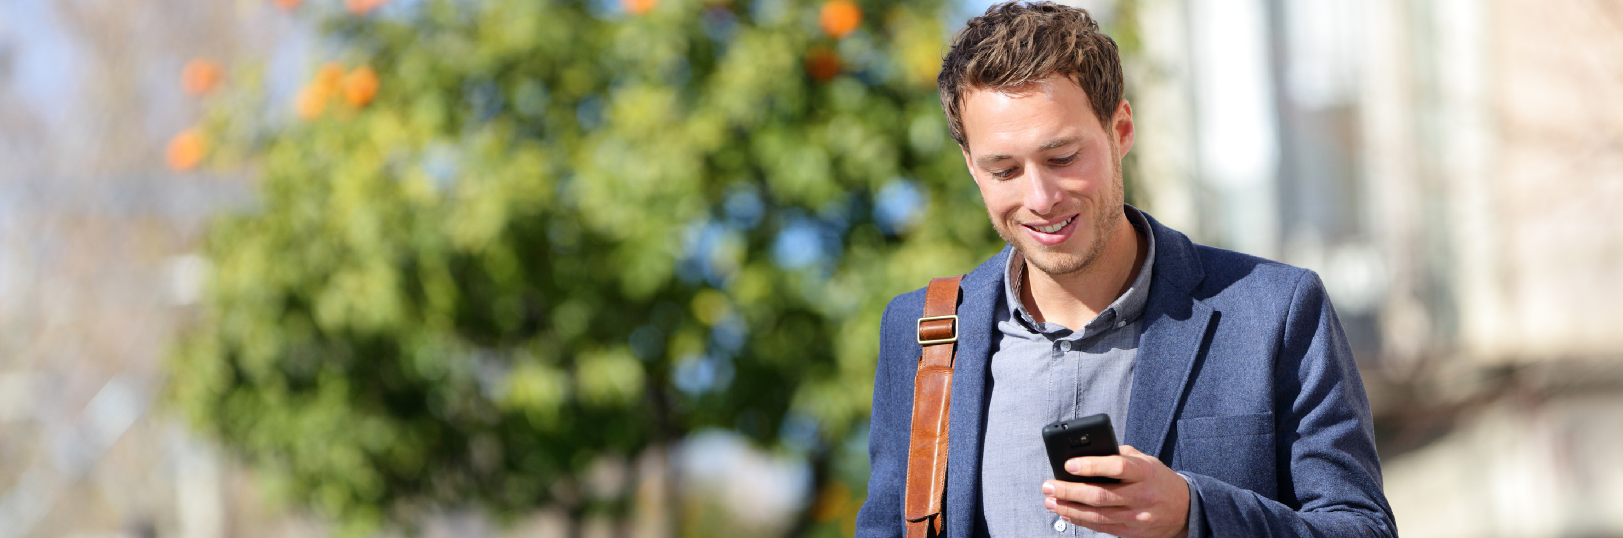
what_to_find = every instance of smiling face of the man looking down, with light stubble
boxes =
[961,75,1133,275]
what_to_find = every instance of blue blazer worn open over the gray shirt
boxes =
[857,215,1397,538]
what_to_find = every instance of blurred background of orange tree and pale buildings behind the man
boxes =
[0,0,1623,538]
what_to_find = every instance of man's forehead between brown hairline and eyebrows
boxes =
[961,75,1104,153]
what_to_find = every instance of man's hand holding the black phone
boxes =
[1042,445,1190,538]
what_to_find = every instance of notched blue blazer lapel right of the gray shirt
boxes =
[1123,213,1212,460]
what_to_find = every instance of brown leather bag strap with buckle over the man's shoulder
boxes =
[902,275,964,538]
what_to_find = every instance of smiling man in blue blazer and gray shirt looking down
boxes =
[857,3,1396,538]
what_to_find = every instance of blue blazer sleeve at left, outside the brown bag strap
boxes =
[857,293,923,538]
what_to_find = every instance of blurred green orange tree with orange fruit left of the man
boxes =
[169,0,1001,533]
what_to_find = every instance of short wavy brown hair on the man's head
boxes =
[935,2,1123,148]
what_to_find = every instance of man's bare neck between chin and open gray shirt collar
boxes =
[1021,213,1149,330]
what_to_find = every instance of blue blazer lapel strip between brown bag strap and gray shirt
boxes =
[943,247,1010,536]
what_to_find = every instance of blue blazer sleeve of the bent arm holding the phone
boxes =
[1190,271,1397,536]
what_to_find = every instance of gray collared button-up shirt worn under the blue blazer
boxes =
[980,206,1201,538]
